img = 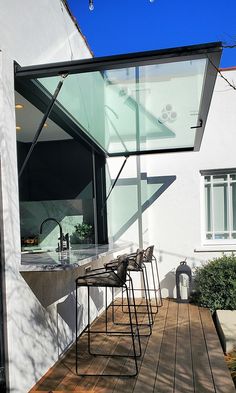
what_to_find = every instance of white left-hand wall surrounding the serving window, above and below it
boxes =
[0,0,91,393]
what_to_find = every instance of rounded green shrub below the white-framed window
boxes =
[195,254,236,312]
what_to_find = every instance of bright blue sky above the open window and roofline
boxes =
[68,0,236,67]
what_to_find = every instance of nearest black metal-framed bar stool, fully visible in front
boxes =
[76,256,141,377]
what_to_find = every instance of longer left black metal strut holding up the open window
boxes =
[19,75,67,179]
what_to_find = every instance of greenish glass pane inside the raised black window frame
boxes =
[38,59,207,154]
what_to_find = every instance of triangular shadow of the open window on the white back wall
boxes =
[111,173,176,241]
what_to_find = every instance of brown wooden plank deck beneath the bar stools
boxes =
[30,300,235,393]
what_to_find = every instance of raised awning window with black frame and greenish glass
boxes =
[16,43,221,156]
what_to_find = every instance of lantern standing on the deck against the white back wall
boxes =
[175,261,192,303]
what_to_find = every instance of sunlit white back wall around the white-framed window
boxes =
[108,70,236,297]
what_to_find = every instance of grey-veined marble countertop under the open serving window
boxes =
[20,242,132,272]
